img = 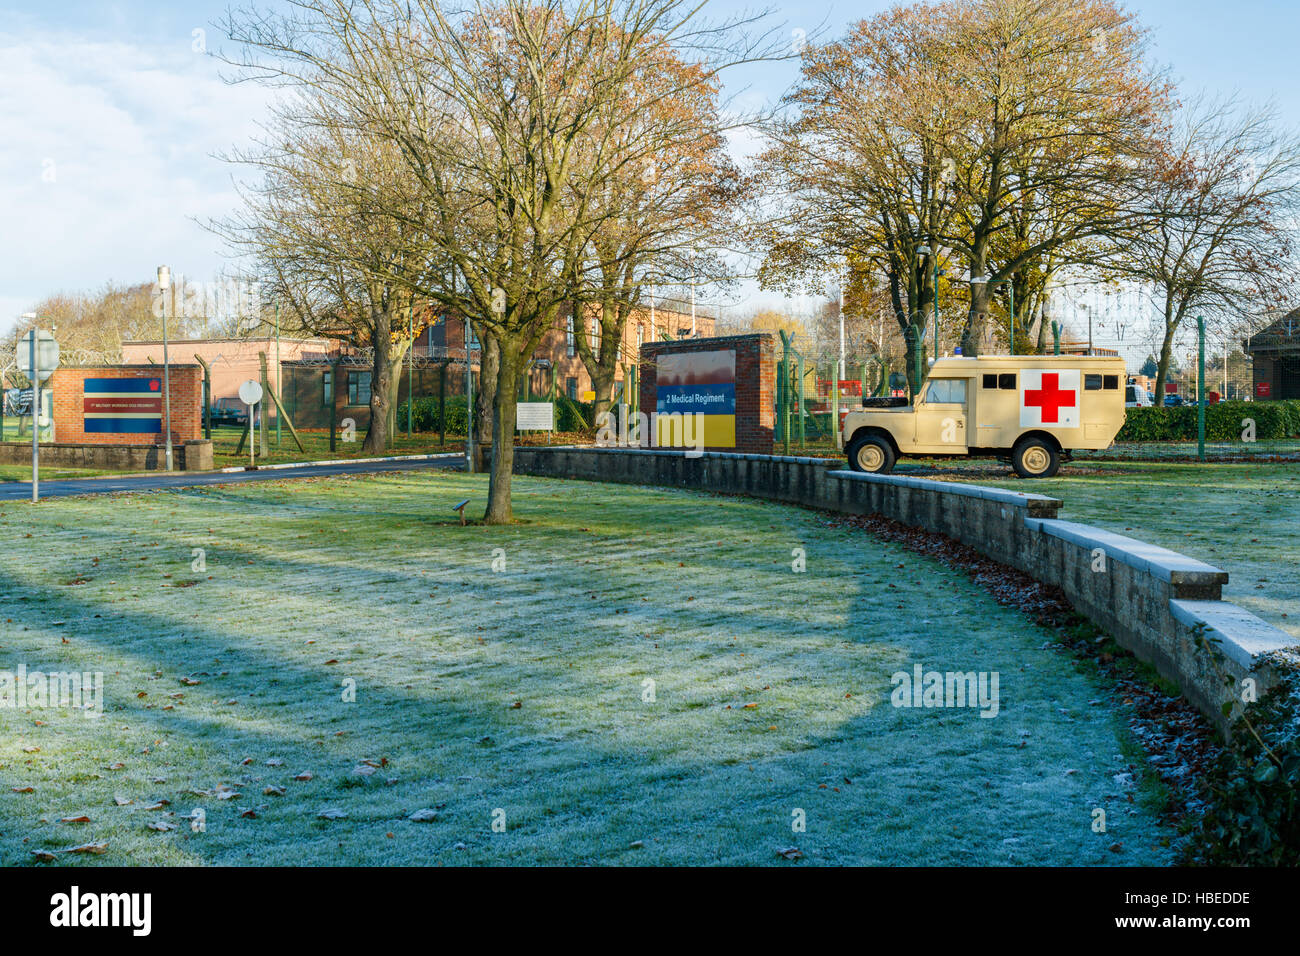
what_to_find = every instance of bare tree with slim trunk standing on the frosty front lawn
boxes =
[220,0,780,523]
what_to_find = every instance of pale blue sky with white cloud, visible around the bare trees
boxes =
[0,0,1300,356]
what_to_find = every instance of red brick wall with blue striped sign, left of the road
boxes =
[51,365,203,445]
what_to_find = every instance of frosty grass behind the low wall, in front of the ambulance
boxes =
[976,462,1300,639]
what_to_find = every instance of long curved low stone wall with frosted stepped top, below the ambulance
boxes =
[515,447,1300,731]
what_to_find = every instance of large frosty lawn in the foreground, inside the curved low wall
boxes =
[0,472,1173,866]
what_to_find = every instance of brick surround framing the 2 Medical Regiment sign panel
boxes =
[640,332,776,455]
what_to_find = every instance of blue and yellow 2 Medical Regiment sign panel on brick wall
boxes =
[655,350,736,449]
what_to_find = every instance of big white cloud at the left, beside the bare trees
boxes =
[0,33,268,332]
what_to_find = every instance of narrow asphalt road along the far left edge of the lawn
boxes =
[0,455,464,501]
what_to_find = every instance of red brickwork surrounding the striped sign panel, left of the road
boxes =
[51,365,203,445]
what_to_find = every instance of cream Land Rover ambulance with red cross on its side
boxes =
[842,355,1125,477]
